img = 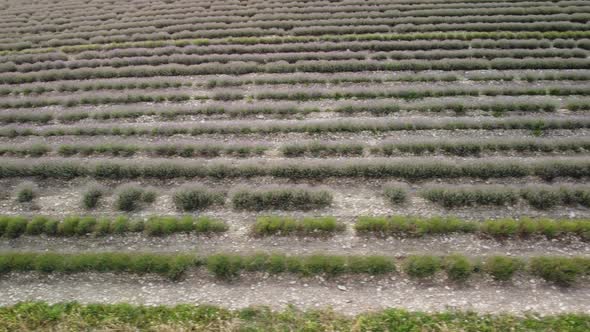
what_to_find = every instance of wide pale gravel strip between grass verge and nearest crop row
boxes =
[0,271,590,314]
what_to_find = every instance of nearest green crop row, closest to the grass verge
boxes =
[0,252,590,286]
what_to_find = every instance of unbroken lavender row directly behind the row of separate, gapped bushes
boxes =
[0,159,590,180]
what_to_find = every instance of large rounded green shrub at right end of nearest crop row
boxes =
[530,257,584,286]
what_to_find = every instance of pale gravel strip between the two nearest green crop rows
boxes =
[0,231,590,257]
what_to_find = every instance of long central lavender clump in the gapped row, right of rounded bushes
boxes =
[231,188,332,211]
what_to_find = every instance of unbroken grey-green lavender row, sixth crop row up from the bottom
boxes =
[0,117,590,137]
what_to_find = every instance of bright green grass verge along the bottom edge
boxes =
[0,302,590,332]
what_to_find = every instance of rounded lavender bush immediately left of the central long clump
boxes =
[172,185,225,211]
